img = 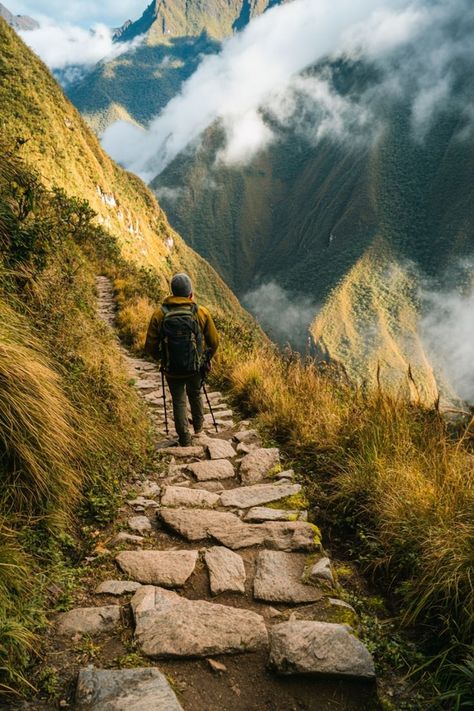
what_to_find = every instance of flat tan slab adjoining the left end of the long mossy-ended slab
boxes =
[159,508,241,541]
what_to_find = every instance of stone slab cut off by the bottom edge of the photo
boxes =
[75,667,183,711]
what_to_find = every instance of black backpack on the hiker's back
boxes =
[160,304,204,375]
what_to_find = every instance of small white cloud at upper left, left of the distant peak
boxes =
[20,20,142,70]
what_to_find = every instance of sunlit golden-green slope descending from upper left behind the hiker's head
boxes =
[0,20,250,321]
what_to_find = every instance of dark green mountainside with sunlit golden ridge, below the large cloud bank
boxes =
[152,67,474,397]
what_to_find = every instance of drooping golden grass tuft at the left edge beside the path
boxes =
[0,302,79,520]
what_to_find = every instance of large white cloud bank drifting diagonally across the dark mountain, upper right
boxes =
[103,0,473,180]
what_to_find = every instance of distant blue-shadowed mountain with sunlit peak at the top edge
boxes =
[67,0,278,133]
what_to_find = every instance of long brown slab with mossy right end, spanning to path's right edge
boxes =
[210,519,319,551]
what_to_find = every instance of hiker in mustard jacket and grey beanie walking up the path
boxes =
[145,273,219,447]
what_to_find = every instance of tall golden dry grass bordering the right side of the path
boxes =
[215,344,474,660]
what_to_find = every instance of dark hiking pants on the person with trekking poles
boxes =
[166,373,204,446]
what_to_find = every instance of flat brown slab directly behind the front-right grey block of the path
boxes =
[253,551,322,604]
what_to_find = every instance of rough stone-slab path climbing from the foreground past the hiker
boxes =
[62,277,378,711]
